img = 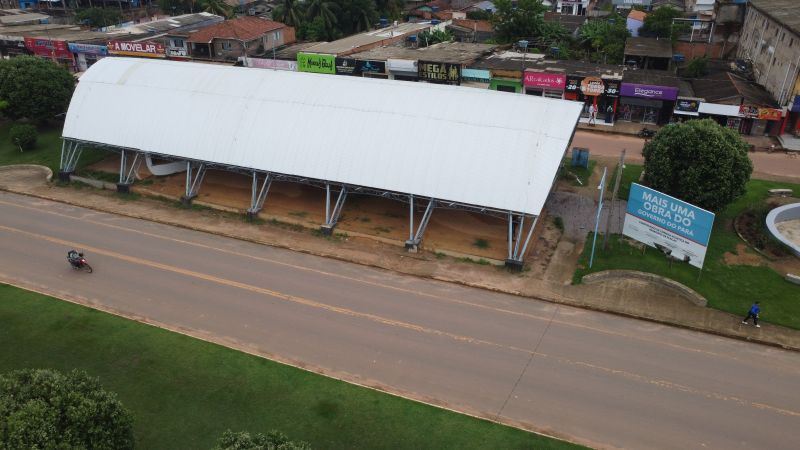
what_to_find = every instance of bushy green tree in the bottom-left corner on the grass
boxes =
[0,369,134,450]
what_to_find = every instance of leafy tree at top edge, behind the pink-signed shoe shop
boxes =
[492,0,547,43]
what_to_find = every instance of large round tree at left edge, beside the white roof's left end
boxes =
[0,56,75,122]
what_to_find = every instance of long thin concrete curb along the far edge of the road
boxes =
[0,166,800,352]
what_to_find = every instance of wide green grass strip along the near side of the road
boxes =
[0,284,581,449]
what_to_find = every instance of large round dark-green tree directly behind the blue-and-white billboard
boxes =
[642,119,753,211]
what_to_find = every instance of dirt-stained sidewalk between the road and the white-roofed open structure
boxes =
[0,166,800,351]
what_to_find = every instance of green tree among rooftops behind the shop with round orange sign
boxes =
[578,14,631,62]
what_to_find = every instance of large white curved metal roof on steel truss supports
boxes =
[63,58,581,215]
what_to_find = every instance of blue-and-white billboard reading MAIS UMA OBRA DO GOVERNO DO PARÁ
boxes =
[622,183,714,269]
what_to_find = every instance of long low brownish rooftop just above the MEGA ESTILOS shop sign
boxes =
[350,42,497,64]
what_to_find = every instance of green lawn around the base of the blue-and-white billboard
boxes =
[573,180,800,329]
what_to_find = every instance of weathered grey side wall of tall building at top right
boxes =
[737,6,800,106]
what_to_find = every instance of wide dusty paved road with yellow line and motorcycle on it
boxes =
[0,192,800,449]
